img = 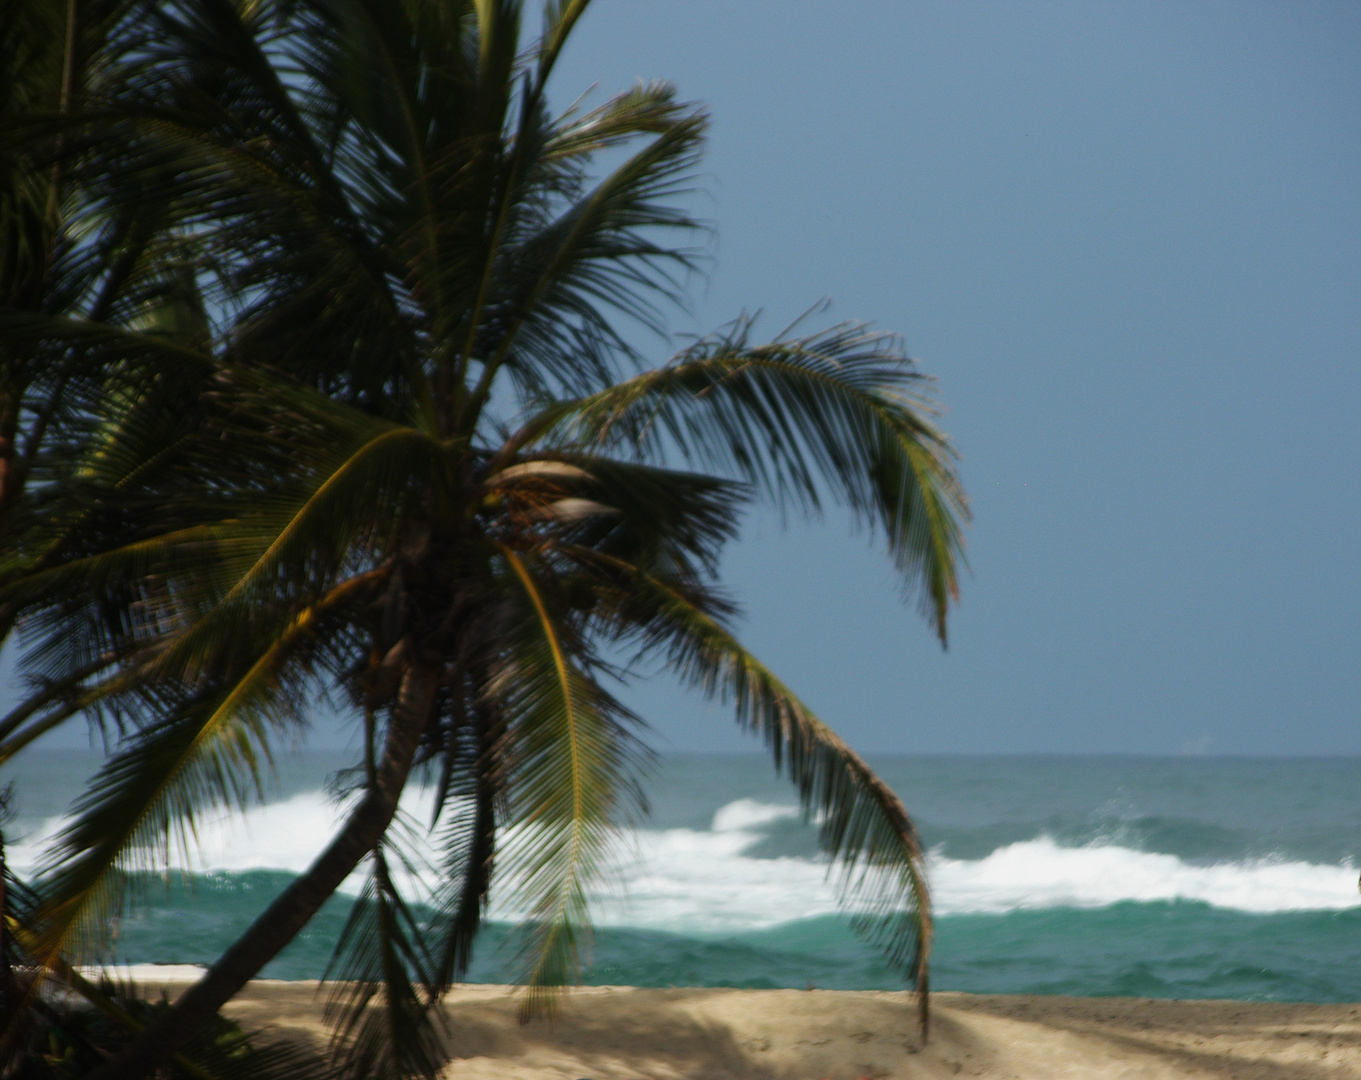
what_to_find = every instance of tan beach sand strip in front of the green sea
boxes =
[125,979,1361,1080]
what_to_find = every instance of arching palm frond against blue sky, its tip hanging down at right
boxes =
[516,320,968,641]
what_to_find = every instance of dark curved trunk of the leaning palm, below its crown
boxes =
[87,665,440,1080]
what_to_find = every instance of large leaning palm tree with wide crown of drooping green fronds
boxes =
[0,0,966,1077]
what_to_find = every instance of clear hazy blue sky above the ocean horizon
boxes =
[21,0,1361,755]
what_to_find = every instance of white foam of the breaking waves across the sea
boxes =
[10,789,1361,933]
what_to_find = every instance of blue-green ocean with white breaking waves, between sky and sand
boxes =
[0,751,1361,1002]
